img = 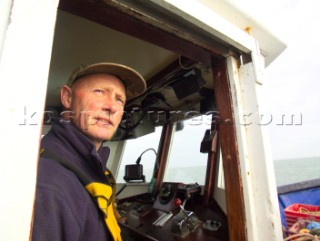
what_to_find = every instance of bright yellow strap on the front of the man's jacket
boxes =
[85,182,122,241]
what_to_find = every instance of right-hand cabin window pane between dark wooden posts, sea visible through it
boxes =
[164,116,210,185]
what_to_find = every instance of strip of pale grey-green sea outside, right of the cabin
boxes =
[274,157,320,186]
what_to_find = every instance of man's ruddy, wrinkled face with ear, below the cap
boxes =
[61,74,126,148]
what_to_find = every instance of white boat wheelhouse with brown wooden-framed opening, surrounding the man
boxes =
[0,0,285,241]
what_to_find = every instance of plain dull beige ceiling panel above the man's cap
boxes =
[46,11,178,106]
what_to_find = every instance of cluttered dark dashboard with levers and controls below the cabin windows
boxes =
[117,182,229,241]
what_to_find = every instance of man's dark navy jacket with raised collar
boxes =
[32,122,113,241]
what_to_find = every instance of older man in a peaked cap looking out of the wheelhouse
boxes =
[32,63,146,241]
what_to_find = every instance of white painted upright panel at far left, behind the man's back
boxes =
[0,0,58,241]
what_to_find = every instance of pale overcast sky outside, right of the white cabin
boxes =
[255,0,320,160]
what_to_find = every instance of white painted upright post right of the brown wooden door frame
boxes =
[228,57,283,241]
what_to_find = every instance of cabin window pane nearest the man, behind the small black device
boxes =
[117,126,162,183]
